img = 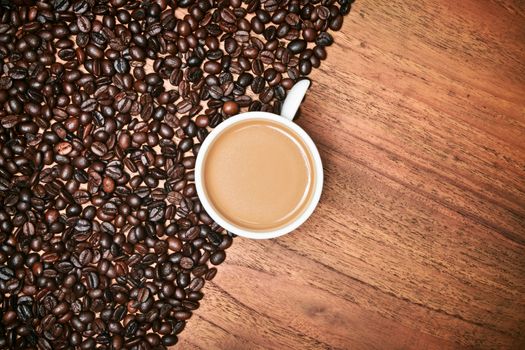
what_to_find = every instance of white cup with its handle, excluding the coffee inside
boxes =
[195,79,323,239]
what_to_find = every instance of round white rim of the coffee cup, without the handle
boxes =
[195,111,324,239]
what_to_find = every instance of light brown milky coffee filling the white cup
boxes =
[202,119,315,231]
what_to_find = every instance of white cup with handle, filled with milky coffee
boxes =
[195,79,323,239]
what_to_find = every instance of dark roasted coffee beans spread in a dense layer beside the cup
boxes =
[0,0,353,350]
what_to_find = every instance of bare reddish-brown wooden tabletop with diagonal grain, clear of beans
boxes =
[179,0,525,350]
